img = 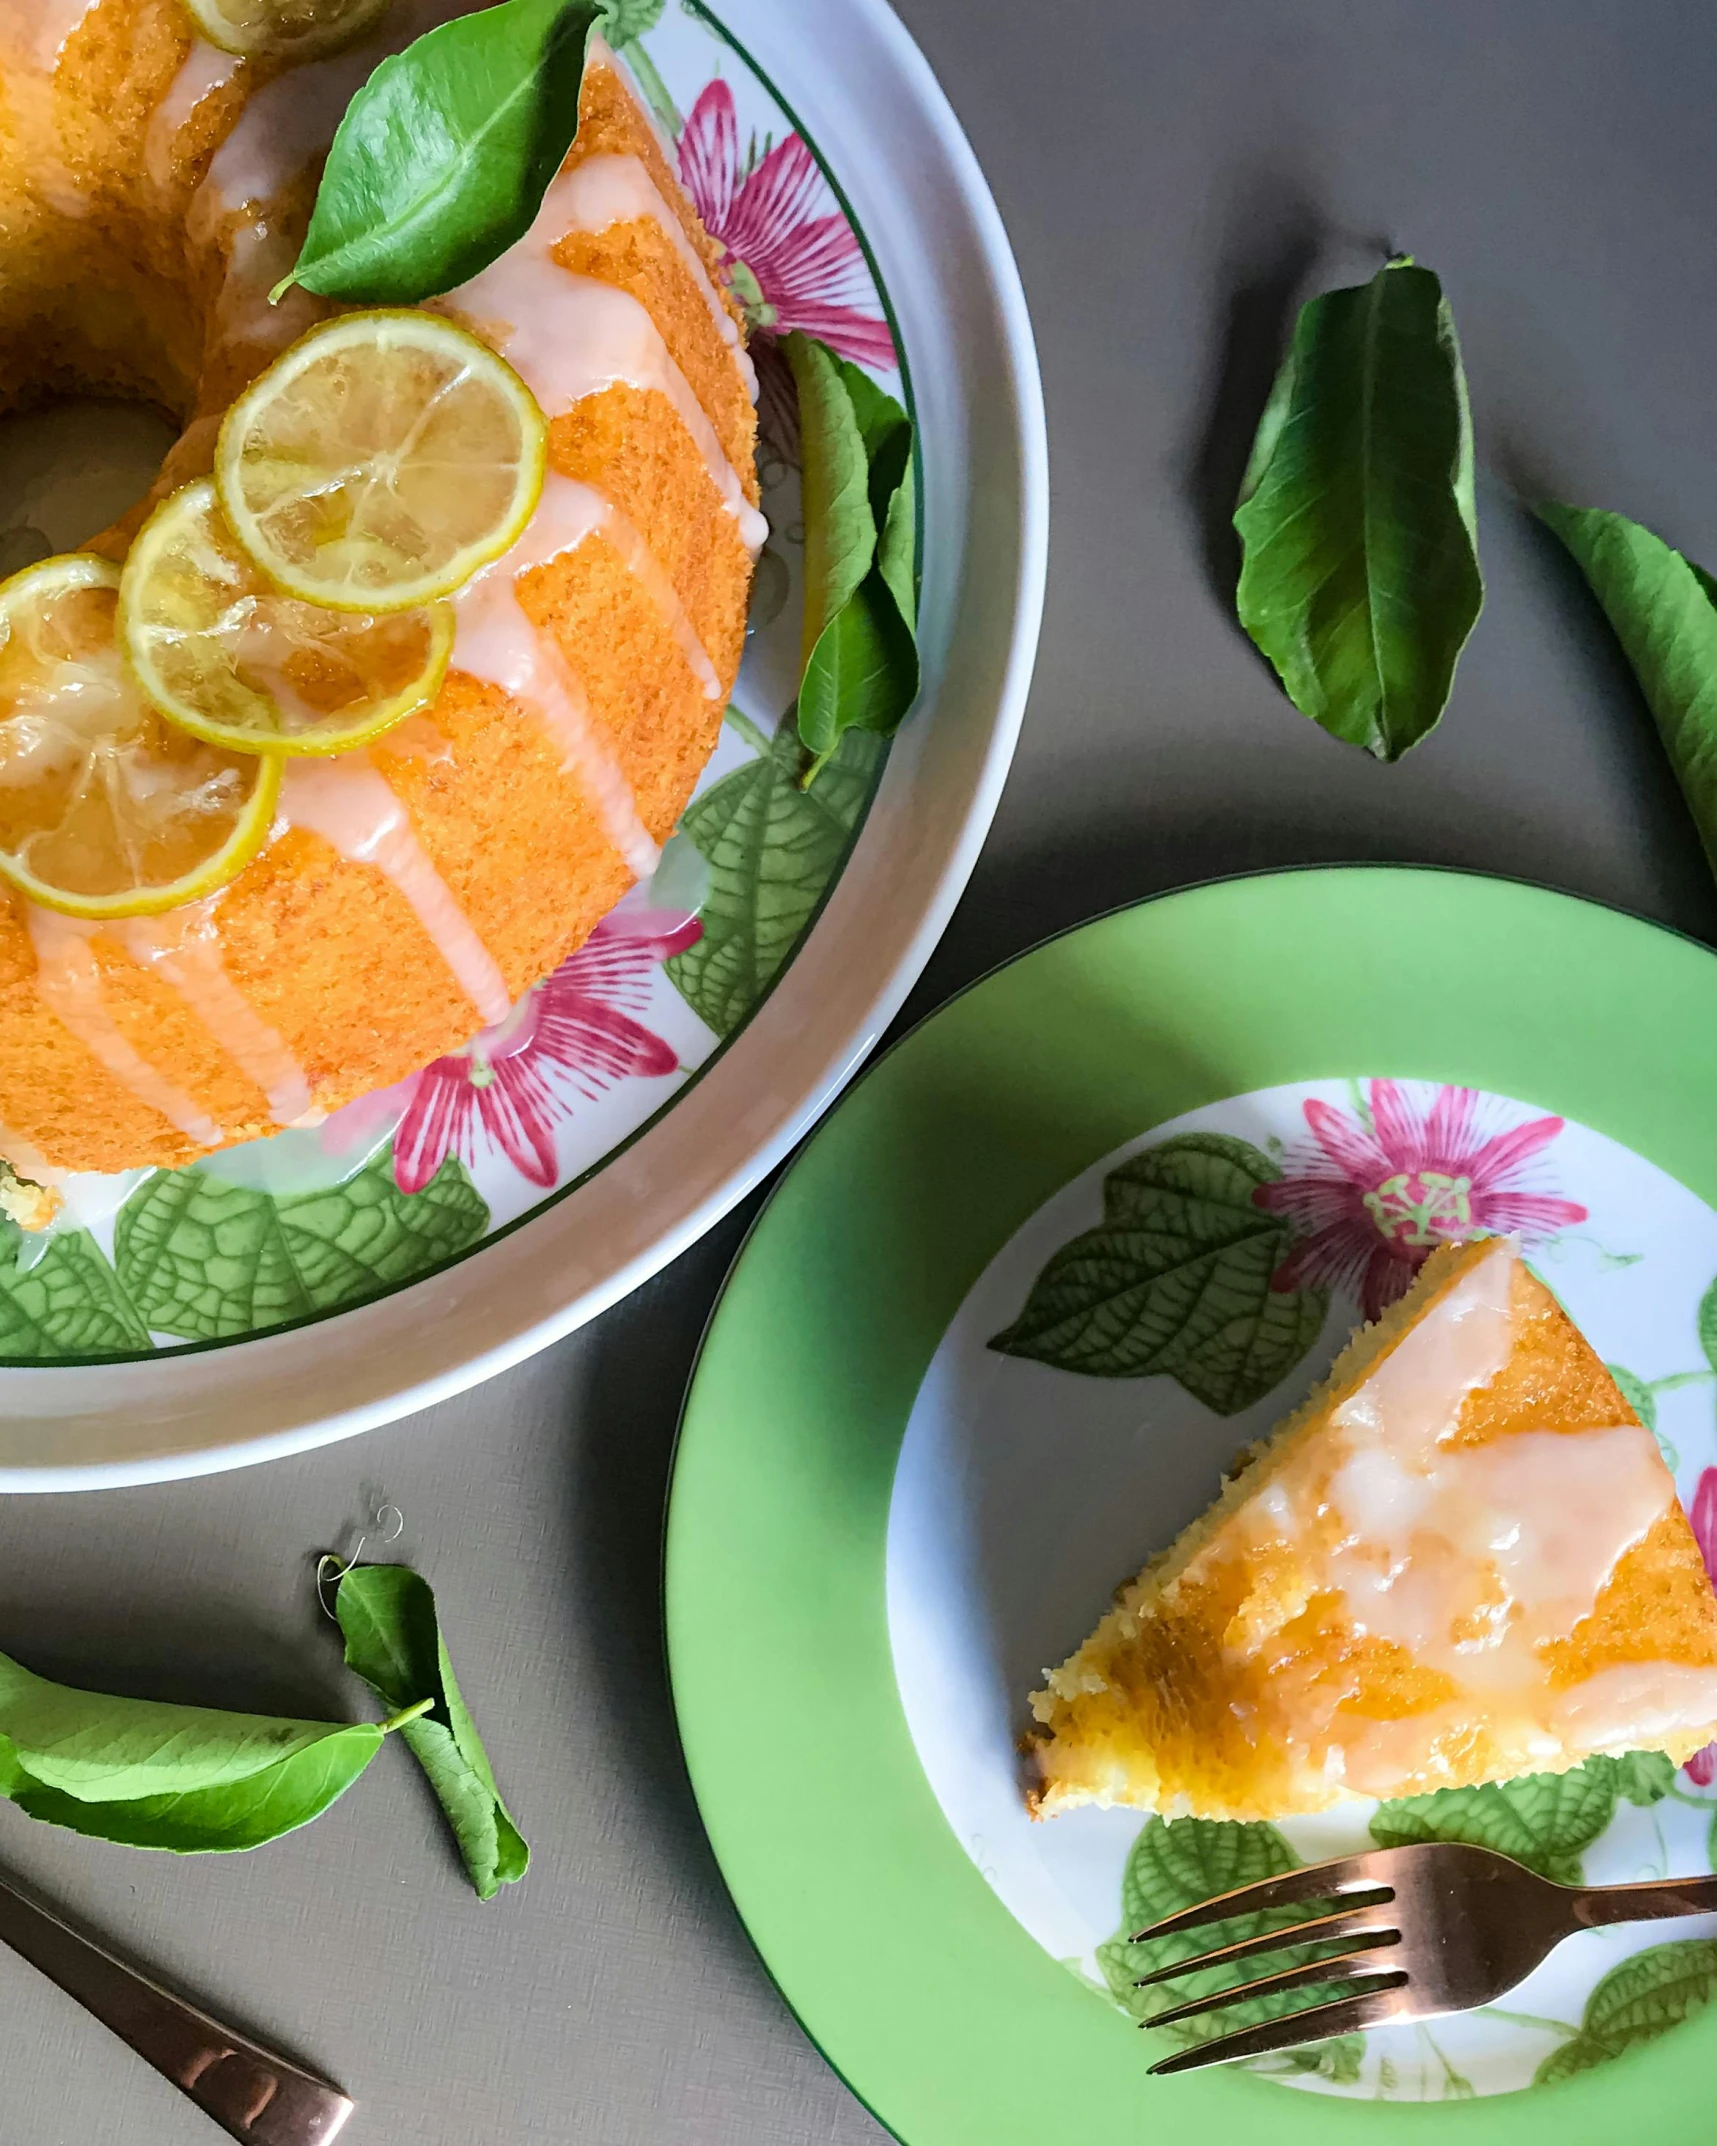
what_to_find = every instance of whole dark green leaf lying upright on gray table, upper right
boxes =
[1234,262,1483,760]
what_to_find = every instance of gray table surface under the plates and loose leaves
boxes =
[0,0,1717,2146]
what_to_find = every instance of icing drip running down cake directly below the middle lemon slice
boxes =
[275,753,513,1024]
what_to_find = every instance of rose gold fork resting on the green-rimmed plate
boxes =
[1131,1841,1717,2073]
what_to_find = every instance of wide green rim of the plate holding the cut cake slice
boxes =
[665,867,1717,2146]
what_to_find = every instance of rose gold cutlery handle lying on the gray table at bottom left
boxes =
[0,1880,354,2146]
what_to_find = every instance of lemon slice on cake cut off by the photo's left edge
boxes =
[0,552,281,916]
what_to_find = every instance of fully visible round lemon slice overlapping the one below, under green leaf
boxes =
[215,311,547,612]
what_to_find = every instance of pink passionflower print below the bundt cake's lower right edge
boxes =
[388,910,702,1193]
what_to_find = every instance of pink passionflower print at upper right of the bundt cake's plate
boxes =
[680,79,895,371]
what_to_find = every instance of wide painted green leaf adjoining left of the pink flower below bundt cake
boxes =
[114,1150,489,1341]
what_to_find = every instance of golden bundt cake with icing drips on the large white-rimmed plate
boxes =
[0,0,764,1184]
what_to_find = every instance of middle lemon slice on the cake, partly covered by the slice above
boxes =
[118,479,453,753]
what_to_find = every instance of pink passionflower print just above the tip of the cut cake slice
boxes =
[1251,1079,1586,1320]
